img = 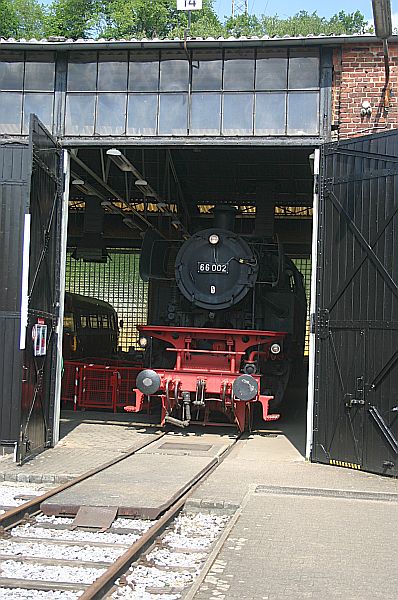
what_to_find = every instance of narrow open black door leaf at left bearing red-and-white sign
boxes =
[17,114,69,463]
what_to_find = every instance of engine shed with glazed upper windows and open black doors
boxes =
[0,36,398,476]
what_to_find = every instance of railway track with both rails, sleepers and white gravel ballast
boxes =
[0,433,239,600]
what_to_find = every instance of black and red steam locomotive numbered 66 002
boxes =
[125,207,306,431]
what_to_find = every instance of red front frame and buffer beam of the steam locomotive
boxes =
[125,325,287,431]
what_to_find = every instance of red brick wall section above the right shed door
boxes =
[332,42,398,139]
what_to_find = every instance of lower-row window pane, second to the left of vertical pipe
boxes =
[127,94,158,135]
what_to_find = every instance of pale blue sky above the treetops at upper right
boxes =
[214,0,398,26]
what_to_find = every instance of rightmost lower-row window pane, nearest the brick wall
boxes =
[287,92,319,135]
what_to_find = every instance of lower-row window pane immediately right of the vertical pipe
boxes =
[189,93,221,135]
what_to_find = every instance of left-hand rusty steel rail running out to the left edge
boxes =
[0,431,167,533]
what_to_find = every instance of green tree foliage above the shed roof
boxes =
[0,0,373,39]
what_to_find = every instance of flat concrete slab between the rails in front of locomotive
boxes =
[41,433,235,519]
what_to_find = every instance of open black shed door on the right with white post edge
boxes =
[306,130,398,476]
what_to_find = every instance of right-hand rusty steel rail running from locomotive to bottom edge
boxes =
[79,434,242,600]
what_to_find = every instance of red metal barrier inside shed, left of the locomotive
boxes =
[61,361,142,412]
